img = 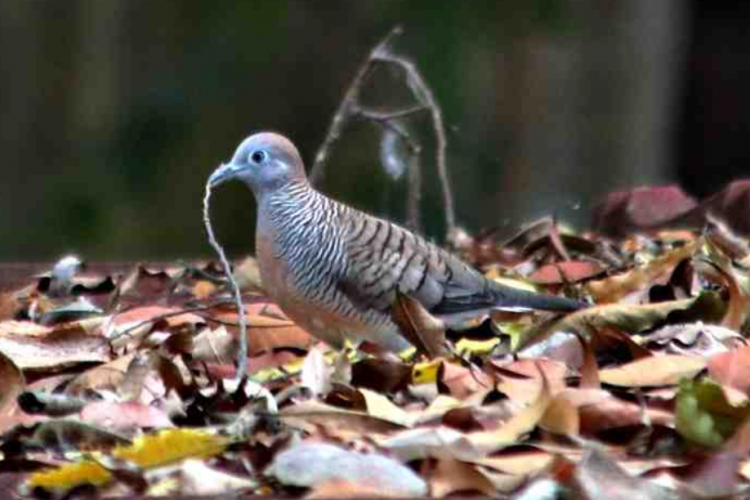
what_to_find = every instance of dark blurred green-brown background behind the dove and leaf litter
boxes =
[0,0,750,260]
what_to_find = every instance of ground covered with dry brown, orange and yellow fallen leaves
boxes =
[0,186,750,499]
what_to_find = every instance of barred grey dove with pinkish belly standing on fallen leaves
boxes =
[208,132,585,351]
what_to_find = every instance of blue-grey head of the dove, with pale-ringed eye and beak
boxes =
[209,132,306,195]
